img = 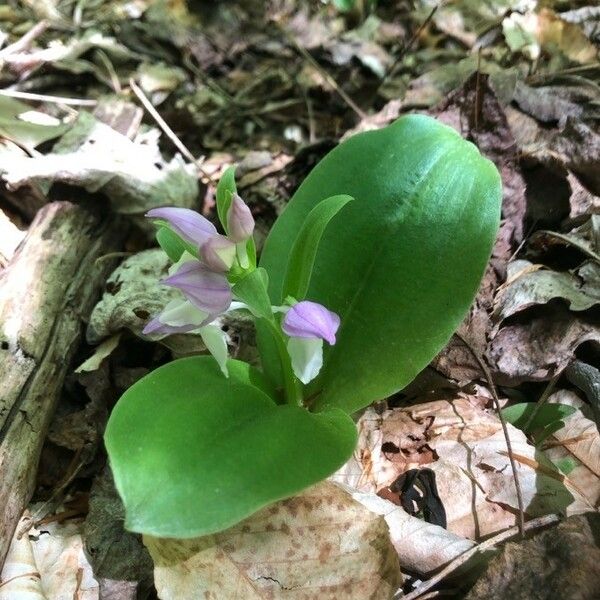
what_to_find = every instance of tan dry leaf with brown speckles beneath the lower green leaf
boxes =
[144,482,401,600]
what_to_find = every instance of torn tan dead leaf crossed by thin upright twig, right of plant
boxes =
[336,393,591,539]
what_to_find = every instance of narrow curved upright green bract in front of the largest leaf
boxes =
[283,195,352,300]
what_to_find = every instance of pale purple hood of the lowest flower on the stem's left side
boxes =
[163,260,232,316]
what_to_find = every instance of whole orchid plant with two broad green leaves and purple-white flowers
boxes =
[105,115,501,538]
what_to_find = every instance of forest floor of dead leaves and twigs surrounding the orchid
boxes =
[0,0,600,600]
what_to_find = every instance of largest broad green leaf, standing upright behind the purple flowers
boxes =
[259,115,502,412]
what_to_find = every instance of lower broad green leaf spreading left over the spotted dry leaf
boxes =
[105,356,356,538]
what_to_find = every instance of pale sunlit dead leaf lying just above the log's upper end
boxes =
[0,112,198,214]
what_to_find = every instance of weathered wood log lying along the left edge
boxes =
[0,202,125,571]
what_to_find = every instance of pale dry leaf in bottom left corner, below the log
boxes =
[0,514,99,600]
